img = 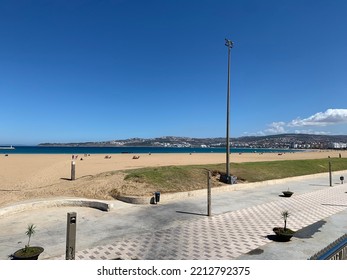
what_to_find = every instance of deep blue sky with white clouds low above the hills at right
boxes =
[0,0,347,144]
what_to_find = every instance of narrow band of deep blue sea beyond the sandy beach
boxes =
[0,146,302,155]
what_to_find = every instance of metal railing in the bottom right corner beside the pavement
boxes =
[309,234,347,260]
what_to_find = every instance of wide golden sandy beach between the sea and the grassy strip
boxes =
[0,151,347,207]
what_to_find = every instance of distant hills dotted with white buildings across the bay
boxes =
[39,134,347,149]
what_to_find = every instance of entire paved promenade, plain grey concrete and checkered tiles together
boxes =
[0,171,347,260]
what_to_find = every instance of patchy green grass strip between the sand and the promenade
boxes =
[124,158,347,192]
